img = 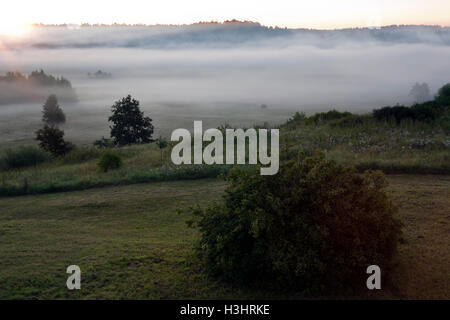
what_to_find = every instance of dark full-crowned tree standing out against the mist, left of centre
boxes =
[108,95,153,146]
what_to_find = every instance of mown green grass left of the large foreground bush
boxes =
[0,180,266,299]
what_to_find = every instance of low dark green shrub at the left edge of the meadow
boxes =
[0,146,51,170]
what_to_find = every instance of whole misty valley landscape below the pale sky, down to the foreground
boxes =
[0,20,450,300]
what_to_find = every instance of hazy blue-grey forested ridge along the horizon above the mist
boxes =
[5,20,450,48]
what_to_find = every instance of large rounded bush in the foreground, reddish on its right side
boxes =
[190,155,401,293]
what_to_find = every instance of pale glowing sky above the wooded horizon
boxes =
[0,0,450,35]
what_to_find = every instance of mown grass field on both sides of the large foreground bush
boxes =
[0,175,450,299]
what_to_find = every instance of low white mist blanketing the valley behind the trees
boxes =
[0,27,450,142]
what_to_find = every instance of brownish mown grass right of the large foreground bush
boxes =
[388,175,450,300]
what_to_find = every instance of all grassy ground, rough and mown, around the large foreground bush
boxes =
[0,105,450,299]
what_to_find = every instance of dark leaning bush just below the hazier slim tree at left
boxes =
[36,125,75,156]
